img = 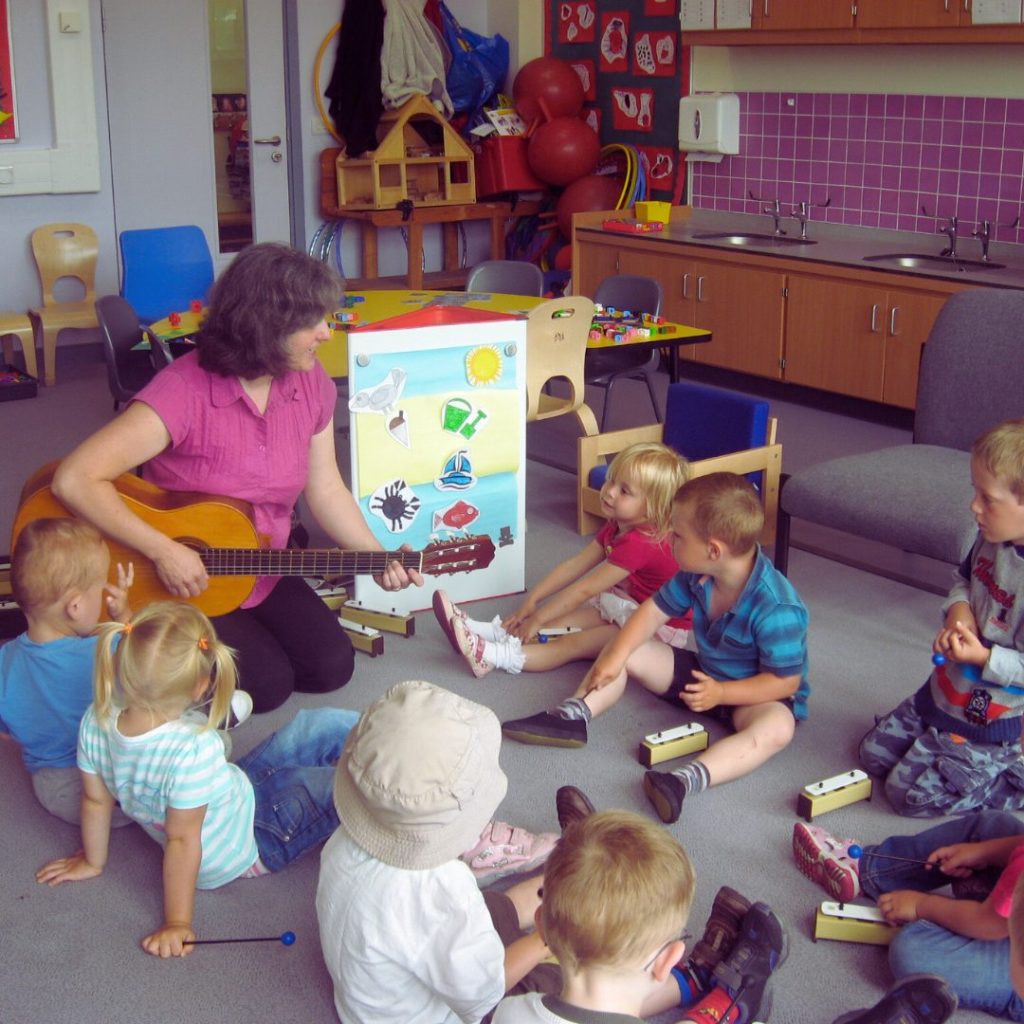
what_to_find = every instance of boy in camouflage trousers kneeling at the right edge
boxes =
[860,420,1024,817]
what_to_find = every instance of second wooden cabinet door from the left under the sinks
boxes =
[692,260,785,380]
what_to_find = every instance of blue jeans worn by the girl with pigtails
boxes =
[238,708,359,871]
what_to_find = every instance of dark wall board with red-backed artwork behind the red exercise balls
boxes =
[547,0,686,198]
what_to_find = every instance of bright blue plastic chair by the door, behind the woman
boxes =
[120,224,213,324]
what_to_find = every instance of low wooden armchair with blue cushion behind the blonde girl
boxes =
[577,381,782,546]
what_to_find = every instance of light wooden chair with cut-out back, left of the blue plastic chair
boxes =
[29,224,99,384]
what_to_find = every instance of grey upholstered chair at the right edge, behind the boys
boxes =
[776,288,1024,582]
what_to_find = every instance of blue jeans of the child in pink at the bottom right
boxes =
[860,811,1024,1021]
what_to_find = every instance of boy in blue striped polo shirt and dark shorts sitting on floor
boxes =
[502,473,810,822]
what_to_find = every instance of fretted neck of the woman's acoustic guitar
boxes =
[199,548,423,577]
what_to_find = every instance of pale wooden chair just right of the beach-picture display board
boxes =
[526,299,597,434]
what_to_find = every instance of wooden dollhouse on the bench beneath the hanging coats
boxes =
[335,95,476,210]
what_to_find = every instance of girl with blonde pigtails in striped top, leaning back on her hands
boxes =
[36,602,358,956]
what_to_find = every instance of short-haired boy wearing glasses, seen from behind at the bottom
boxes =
[494,811,784,1024]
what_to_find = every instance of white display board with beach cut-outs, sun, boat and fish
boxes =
[348,306,526,612]
